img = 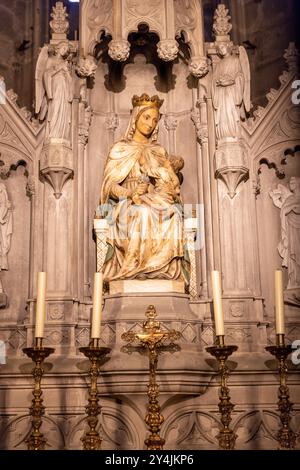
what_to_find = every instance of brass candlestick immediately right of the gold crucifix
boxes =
[206,336,238,450]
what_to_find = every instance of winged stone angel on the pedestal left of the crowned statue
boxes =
[35,41,73,142]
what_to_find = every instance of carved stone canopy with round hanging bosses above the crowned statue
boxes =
[80,0,208,77]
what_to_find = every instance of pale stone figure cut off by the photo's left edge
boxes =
[0,183,12,271]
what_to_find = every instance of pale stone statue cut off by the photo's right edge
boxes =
[269,176,300,289]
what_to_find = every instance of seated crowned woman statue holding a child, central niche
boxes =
[100,94,187,283]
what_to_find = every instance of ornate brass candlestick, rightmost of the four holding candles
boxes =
[266,334,297,449]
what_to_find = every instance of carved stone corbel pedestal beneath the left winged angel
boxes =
[40,139,74,199]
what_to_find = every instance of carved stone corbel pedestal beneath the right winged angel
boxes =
[215,141,249,199]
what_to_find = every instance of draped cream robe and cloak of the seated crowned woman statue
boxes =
[101,140,185,281]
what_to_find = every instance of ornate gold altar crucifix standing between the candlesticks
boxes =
[121,305,181,450]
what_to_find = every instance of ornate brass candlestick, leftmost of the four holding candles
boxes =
[23,338,55,450]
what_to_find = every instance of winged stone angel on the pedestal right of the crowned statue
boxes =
[212,42,250,141]
